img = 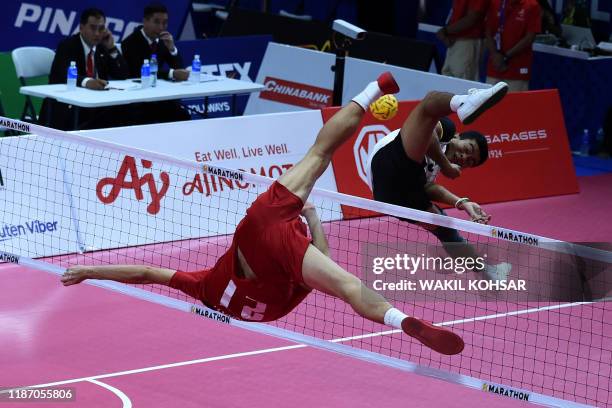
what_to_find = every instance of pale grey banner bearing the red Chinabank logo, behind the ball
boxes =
[245,42,490,115]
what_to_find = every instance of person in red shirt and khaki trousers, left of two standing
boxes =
[437,0,490,81]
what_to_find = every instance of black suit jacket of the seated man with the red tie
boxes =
[49,34,129,86]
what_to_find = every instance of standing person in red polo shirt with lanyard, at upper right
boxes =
[485,0,541,92]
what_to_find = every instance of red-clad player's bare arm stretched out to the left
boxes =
[62,265,176,286]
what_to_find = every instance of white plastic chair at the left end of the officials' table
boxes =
[11,47,55,122]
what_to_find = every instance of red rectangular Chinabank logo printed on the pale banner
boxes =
[259,77,333,109]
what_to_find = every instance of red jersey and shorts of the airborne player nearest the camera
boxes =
[170,182,310,321]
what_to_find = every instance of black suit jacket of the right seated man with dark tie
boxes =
[121,26,183,79]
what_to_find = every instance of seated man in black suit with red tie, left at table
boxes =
[40,8,128,129]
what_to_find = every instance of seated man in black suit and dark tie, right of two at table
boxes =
[121,4,189,123]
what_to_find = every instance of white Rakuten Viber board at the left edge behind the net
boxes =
[0,136,78,257]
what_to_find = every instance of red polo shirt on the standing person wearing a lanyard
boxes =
[486,0,542,80]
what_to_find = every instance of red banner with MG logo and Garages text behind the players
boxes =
[322,90,578,217]
